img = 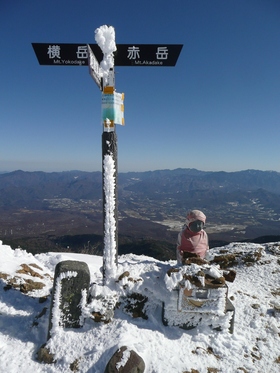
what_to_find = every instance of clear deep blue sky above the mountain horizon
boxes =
[0,0,280,172]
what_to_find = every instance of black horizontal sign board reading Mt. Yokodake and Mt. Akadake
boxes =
[32,43,183,66]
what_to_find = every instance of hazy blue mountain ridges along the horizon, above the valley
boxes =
[0,169,280,207]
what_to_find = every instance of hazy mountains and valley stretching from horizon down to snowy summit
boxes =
[0,169,280,256]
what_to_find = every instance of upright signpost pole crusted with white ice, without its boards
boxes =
[95,25,118,284]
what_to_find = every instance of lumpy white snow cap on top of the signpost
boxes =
[95,25,117,75]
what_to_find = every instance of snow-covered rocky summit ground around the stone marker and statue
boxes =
[0,241,280,373]
